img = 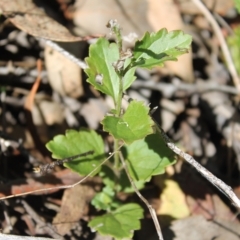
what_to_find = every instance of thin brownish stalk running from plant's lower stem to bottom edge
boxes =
[119,152,163,240]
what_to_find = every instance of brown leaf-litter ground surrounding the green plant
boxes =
[0,0,240,240]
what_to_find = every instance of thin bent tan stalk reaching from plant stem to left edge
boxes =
[0,144,123,200]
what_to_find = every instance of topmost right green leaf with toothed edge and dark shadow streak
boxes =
[132,29,192,68]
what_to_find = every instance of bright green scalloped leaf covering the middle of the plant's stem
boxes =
[102,100,154,144]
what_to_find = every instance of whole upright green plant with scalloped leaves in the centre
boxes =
[46,21,191,239]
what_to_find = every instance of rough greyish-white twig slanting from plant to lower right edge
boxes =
[152,118,240,209]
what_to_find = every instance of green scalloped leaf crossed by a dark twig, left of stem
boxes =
[46,130,105,175]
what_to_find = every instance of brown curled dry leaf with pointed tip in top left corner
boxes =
[0,0,82,42]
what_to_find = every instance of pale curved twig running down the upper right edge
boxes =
[192,0,240,92]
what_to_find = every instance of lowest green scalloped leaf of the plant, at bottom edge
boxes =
[88,203,143,239]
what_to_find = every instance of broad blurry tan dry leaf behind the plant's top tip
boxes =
[73,0,151,37]
